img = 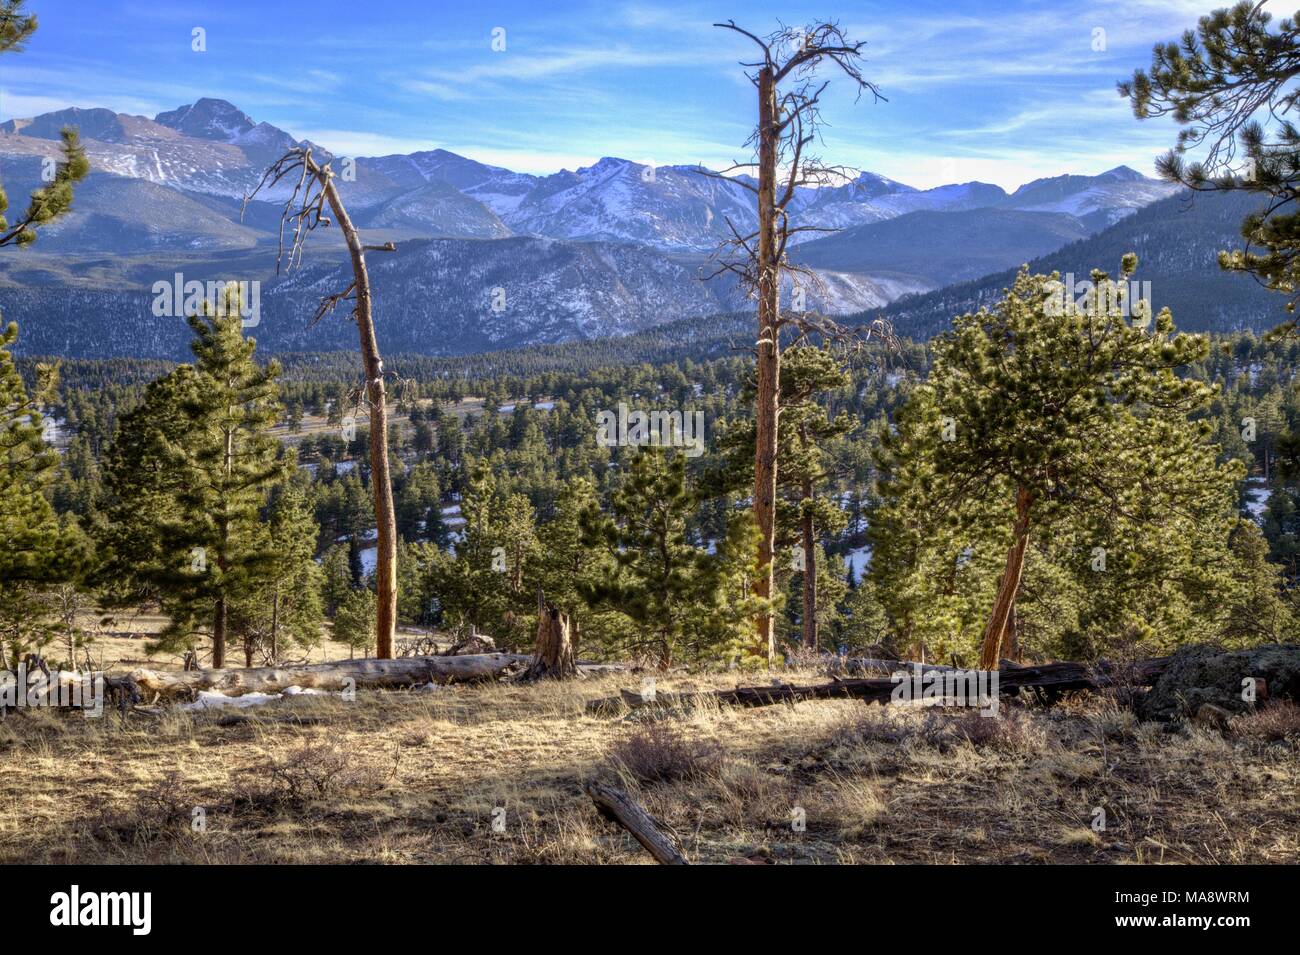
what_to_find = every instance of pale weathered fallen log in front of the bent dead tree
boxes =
[130,654,532,698]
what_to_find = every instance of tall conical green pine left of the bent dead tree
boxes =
[105,288,293,667]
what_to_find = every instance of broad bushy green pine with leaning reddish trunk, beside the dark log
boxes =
[874,255,1242,668]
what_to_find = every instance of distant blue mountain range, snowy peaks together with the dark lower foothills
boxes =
[0,99,1258,357]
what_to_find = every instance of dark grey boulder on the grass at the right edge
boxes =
[1139,643,1300,720]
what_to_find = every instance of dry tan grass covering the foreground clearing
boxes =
[0,674,1300,863]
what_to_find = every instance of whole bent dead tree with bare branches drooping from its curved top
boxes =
[244,146,398,660]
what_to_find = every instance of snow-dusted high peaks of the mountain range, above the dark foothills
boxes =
[0,99,1173,253]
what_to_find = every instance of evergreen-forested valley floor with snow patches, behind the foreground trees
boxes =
[8,314,1300,659]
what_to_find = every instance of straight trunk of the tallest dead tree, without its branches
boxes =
[754,66,781,667]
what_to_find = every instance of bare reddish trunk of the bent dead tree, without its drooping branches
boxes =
[325,177,398,660]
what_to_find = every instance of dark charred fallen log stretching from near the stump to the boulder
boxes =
[586,656,1169,713]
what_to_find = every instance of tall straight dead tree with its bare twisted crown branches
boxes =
[710,21,881,665]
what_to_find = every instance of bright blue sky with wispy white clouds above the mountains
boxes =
[0,0,1225,188]
